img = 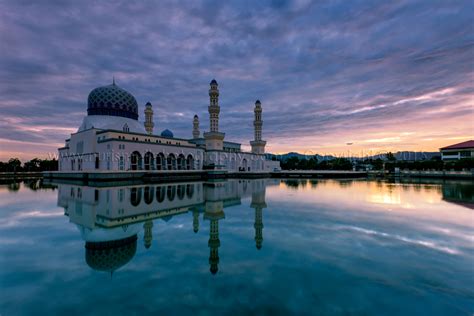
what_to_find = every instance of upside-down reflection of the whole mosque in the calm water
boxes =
[58,179,278,274]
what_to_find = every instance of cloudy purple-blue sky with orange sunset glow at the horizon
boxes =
[0,0,474,160]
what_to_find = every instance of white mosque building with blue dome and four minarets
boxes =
[58,80,280,173]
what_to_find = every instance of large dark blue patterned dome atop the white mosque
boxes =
[87,82,138,120]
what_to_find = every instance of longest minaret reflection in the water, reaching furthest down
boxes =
[204,201,225,274]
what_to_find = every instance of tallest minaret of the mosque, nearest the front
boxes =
[204,79,225,150]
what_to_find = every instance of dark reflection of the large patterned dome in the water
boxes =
[86,235,137,272]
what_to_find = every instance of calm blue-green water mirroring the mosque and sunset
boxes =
[0,179,474,316]
